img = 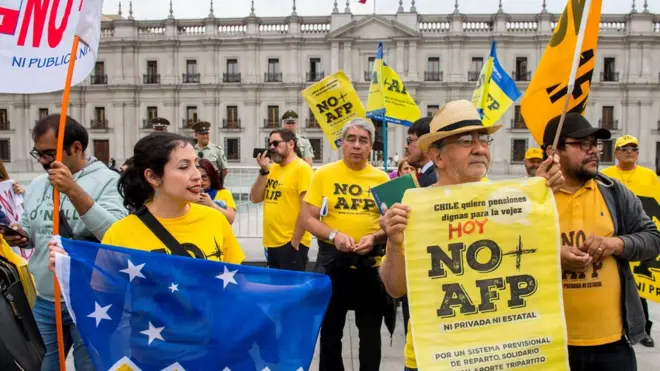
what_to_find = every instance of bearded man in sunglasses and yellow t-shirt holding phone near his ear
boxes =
[250,129,314,271]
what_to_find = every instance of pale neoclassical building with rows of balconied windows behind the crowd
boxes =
[0,0,660,178]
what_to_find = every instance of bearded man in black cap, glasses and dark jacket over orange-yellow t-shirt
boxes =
[543,113,660,371]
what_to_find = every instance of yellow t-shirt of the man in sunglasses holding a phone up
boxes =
[263,158,314,248]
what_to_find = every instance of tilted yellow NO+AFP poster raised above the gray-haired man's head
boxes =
[302,70,366,149]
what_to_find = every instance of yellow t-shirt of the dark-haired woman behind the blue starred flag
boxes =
[102,203,245,264]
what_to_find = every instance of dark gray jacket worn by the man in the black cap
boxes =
[596,173,660,344]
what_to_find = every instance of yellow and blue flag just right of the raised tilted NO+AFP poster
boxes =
[367,43,421,126]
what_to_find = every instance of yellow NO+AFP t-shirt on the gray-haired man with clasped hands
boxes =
[305,160,390,243]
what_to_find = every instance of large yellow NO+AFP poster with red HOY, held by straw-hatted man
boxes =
[403,178,568,371]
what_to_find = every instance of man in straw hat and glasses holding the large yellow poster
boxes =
[380,100,563,371]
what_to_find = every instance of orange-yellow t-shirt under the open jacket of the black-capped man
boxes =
[555,179,623,346]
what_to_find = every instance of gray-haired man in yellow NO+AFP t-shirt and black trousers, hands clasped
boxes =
[305,118,389,371]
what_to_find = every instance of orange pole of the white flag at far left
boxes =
[53,35,80,371]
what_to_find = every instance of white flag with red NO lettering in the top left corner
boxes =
[0,0,103,94]
